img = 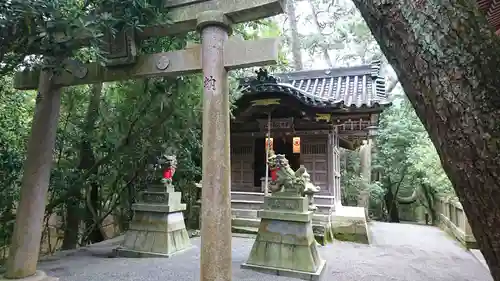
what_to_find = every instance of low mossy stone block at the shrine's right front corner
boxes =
[332,206,370,244]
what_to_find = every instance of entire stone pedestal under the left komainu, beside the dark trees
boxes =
[115,184,191,258]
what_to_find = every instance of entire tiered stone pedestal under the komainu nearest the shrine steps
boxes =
[242,192,325,280]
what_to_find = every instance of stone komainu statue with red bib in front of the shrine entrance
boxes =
[268,150,320,210]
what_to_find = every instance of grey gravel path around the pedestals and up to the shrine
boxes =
[40,223,493,281]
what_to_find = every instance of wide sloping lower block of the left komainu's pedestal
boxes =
[115,212,191,257]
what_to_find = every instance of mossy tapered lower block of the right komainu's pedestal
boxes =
[245,218,324,274]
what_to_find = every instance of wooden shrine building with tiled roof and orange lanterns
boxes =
[231,61,391,236]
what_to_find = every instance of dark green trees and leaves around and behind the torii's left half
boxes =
[0,6,286,252]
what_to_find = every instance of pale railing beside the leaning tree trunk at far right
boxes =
[435,197,477,249]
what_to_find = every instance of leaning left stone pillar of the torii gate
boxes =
[0,68,61,281]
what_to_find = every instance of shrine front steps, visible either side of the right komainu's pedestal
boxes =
[231,191,334,236]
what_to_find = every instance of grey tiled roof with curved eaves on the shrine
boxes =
[240,61,391,109]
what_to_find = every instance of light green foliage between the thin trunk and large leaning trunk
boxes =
[371,92,453,220]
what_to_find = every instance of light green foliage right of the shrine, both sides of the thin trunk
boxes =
[341,92,454,220]
